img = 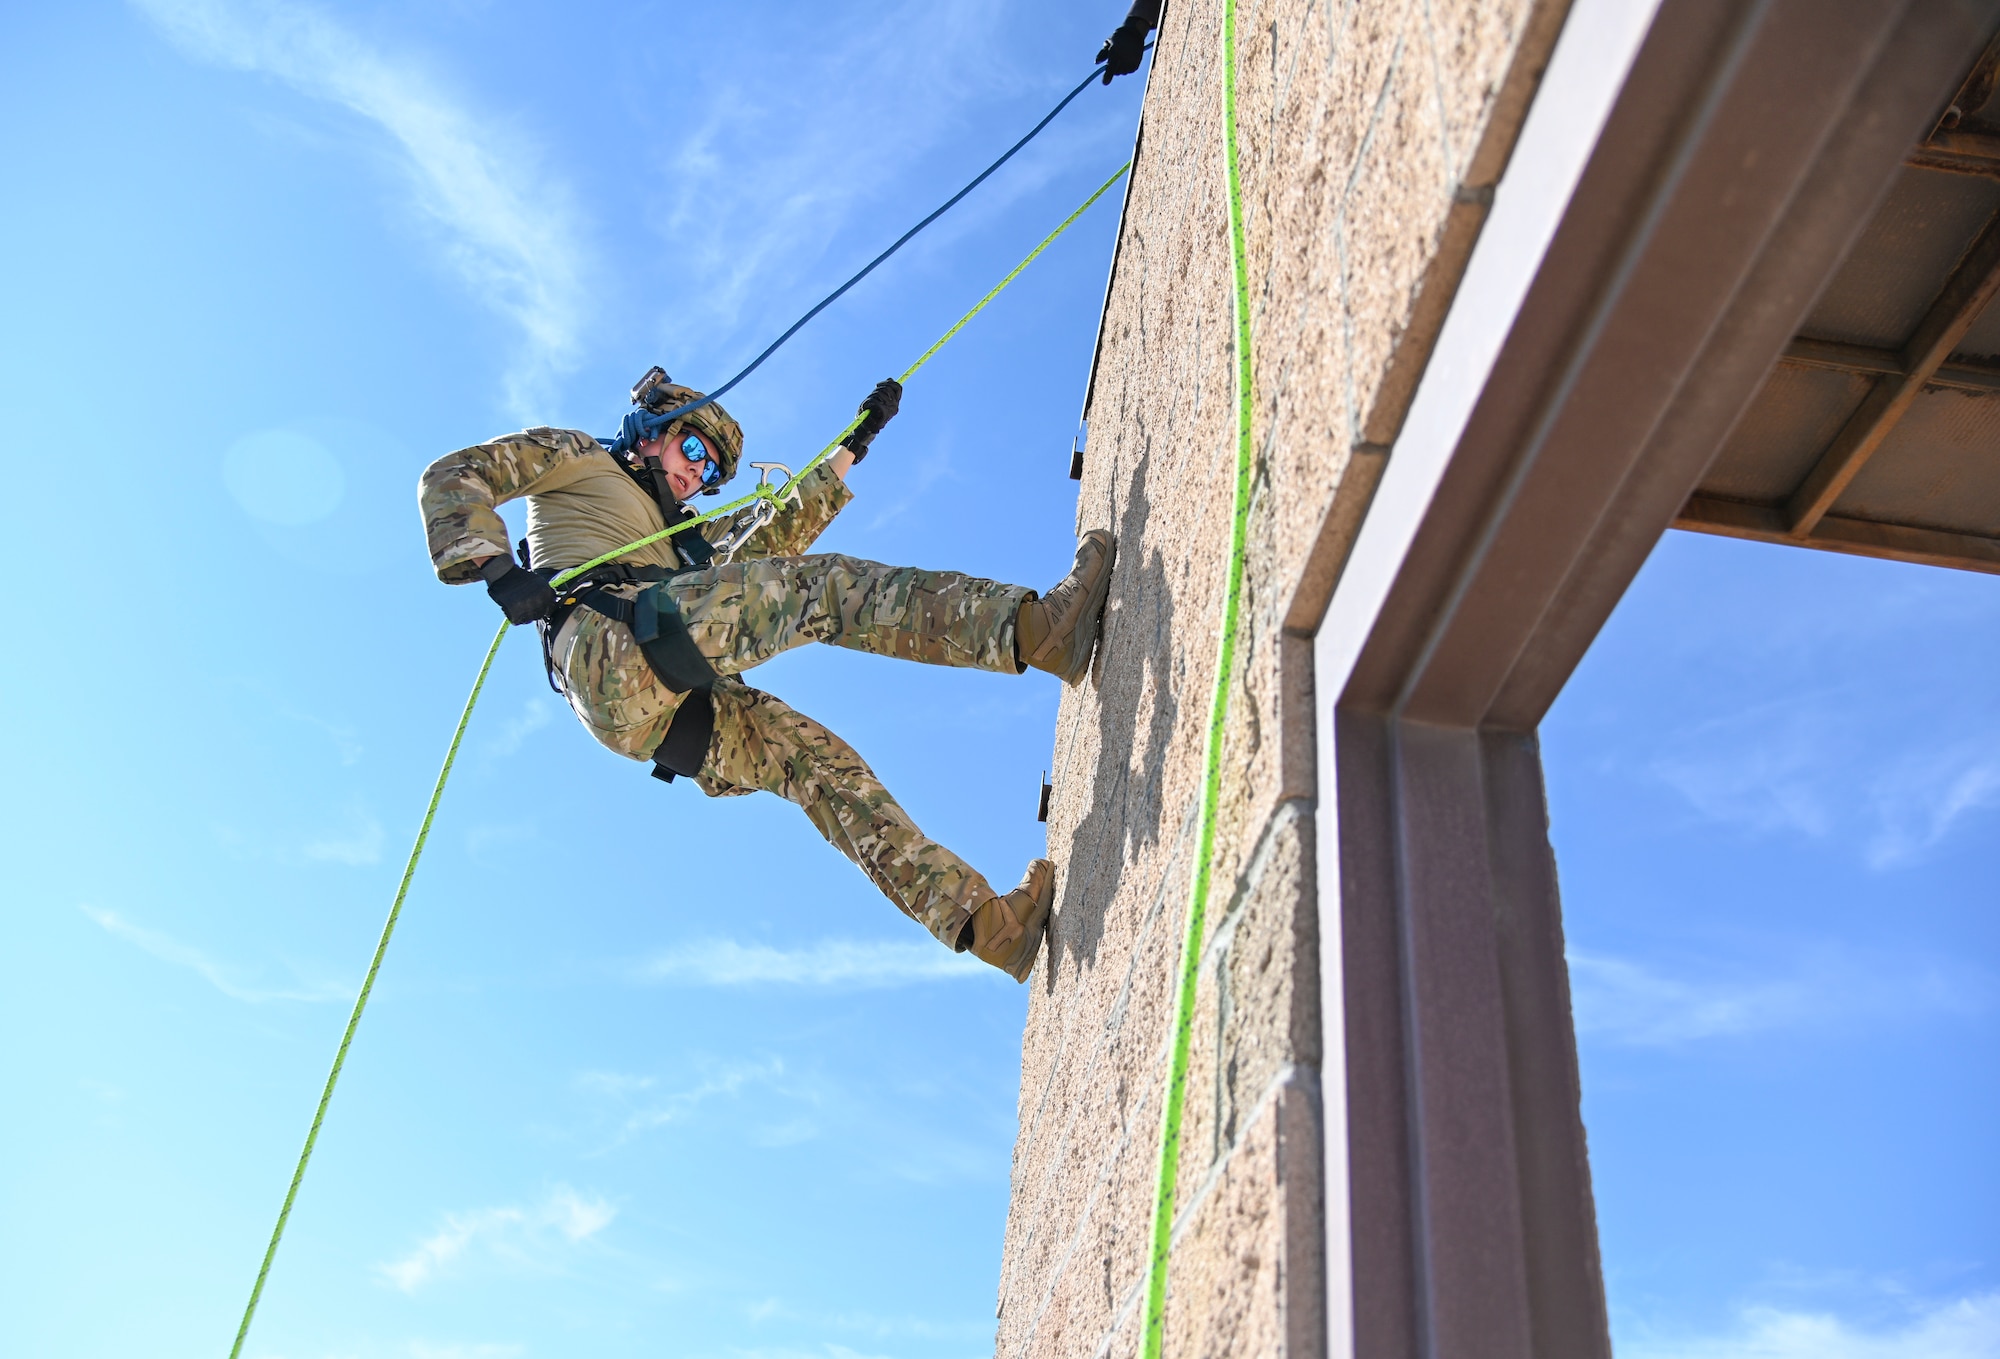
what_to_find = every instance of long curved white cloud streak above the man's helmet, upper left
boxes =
[132,0,586,416]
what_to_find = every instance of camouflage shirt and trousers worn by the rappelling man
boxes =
[418,430,1032,943]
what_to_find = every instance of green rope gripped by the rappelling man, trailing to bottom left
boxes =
[230,160,1132,1359]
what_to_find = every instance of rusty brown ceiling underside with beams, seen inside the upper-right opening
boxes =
[1674,42,2000,572]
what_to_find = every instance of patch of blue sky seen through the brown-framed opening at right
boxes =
[1542,534,2000,1359]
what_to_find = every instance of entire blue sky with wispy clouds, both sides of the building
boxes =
[0,0,2000,1359]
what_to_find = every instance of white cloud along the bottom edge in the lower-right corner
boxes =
[1618,1293,2000,1359]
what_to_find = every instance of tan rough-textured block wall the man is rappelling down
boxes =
[996,0,1568,1359]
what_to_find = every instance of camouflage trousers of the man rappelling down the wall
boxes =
[564,554,1032,943]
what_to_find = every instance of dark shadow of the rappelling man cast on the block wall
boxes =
[1042,448,1180,987]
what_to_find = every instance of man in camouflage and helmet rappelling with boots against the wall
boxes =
[418,368,1112,981]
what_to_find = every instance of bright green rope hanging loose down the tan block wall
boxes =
[1142,0,1252,1359]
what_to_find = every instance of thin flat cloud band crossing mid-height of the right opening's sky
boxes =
[1570,949,1992,1047]
